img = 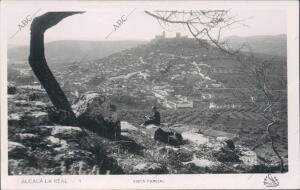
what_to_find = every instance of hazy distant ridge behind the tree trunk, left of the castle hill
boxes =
[8,40,146,61]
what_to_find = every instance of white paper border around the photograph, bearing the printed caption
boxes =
[0,1,300,189]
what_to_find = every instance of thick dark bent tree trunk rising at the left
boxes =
[29,12,82,115]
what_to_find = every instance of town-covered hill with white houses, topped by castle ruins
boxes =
[9,32,286,109]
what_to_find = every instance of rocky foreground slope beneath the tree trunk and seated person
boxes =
[8,84,286,175]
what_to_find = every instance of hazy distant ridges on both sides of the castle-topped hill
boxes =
[8,34,287,64]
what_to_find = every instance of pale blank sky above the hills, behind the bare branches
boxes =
[5,2,287,46]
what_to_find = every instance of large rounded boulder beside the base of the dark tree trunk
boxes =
[72,92,121,138]
